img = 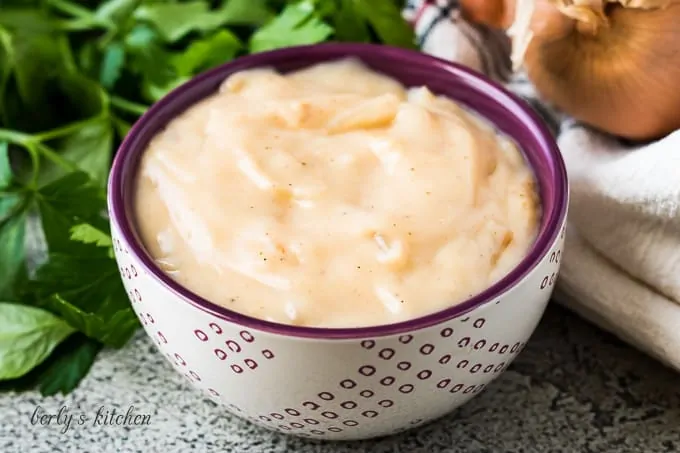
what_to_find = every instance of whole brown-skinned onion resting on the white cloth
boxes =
[461,0,680,140]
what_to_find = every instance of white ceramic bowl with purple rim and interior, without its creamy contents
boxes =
[108,44,568,440]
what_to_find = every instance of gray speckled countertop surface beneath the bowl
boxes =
[0,304,680,453]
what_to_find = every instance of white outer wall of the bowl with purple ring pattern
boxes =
[112,217,565,440]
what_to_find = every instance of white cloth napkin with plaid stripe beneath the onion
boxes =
[404,0,680,370]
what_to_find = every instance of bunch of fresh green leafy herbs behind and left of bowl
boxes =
[0,0,413,395]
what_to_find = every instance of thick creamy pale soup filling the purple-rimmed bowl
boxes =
[135,59,540,327]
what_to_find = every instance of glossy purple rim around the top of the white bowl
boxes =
[107,43,569,340]
